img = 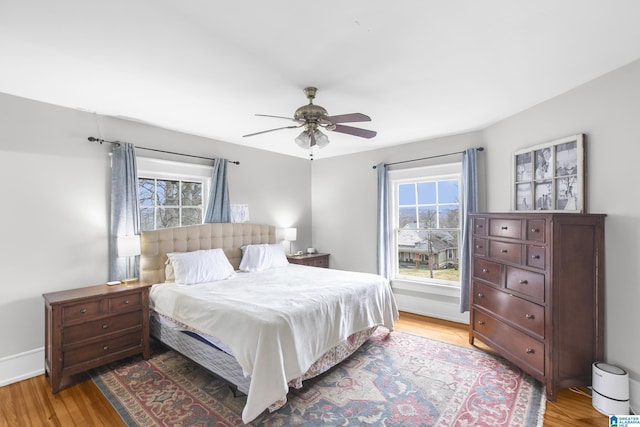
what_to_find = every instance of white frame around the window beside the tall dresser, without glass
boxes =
[389,162,462,290]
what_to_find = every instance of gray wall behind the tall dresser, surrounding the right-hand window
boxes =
[312,61,640,409]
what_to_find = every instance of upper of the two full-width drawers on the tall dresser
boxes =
[473,283,544,339]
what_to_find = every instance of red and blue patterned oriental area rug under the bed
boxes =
[91,330,546,427]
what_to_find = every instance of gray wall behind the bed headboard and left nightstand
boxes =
[0,94,311,362]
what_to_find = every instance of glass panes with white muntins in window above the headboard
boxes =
[138,178,203,231]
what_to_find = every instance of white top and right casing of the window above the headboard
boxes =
[136,157,213,232]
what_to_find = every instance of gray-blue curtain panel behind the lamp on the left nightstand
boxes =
[109,143,140,280]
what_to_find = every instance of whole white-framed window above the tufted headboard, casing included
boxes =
[136,157,212,231]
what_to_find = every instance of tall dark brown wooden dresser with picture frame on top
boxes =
[469,213,605,401]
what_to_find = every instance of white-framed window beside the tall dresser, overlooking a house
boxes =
[389,163,462,286]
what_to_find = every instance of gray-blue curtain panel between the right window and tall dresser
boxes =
[460,148,478,313]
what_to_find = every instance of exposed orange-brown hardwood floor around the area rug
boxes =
[0,313,608,427]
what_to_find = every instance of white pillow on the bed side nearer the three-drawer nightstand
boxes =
[167,249,235,285]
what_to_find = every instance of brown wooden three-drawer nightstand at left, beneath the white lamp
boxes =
[43,282,150,393]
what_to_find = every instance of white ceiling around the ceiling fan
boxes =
[0,0,640,158]
